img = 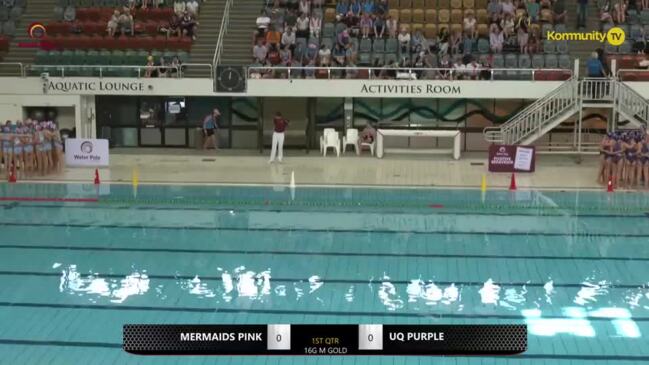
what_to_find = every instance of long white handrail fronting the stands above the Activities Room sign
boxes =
[246,66,573,81]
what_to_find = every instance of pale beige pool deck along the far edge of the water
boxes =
[10,148,624,190]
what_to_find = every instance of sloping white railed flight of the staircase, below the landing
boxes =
[484,79,578,144]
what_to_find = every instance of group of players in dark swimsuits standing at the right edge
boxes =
[597,130,649,189]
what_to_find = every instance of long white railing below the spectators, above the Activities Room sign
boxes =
[247,66,572,81]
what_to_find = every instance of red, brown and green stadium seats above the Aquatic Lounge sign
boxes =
[31,0,193,72]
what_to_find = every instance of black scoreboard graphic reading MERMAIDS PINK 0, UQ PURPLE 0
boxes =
[123,324,527,356]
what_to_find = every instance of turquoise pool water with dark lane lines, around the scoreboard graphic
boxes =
[0,184,649,364]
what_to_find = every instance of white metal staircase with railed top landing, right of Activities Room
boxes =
[483,79,649,145]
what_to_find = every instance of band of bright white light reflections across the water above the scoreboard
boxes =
[52,263,649,338]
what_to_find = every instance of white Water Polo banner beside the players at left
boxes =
[65,138,109,167]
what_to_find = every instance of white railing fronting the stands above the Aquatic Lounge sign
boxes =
[25,63,214,78]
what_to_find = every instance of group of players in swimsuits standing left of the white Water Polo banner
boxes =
[0,119,64,176]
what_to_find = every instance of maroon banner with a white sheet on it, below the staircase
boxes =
[489,145,536,172]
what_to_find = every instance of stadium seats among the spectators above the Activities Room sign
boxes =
[251,0,571,77]
